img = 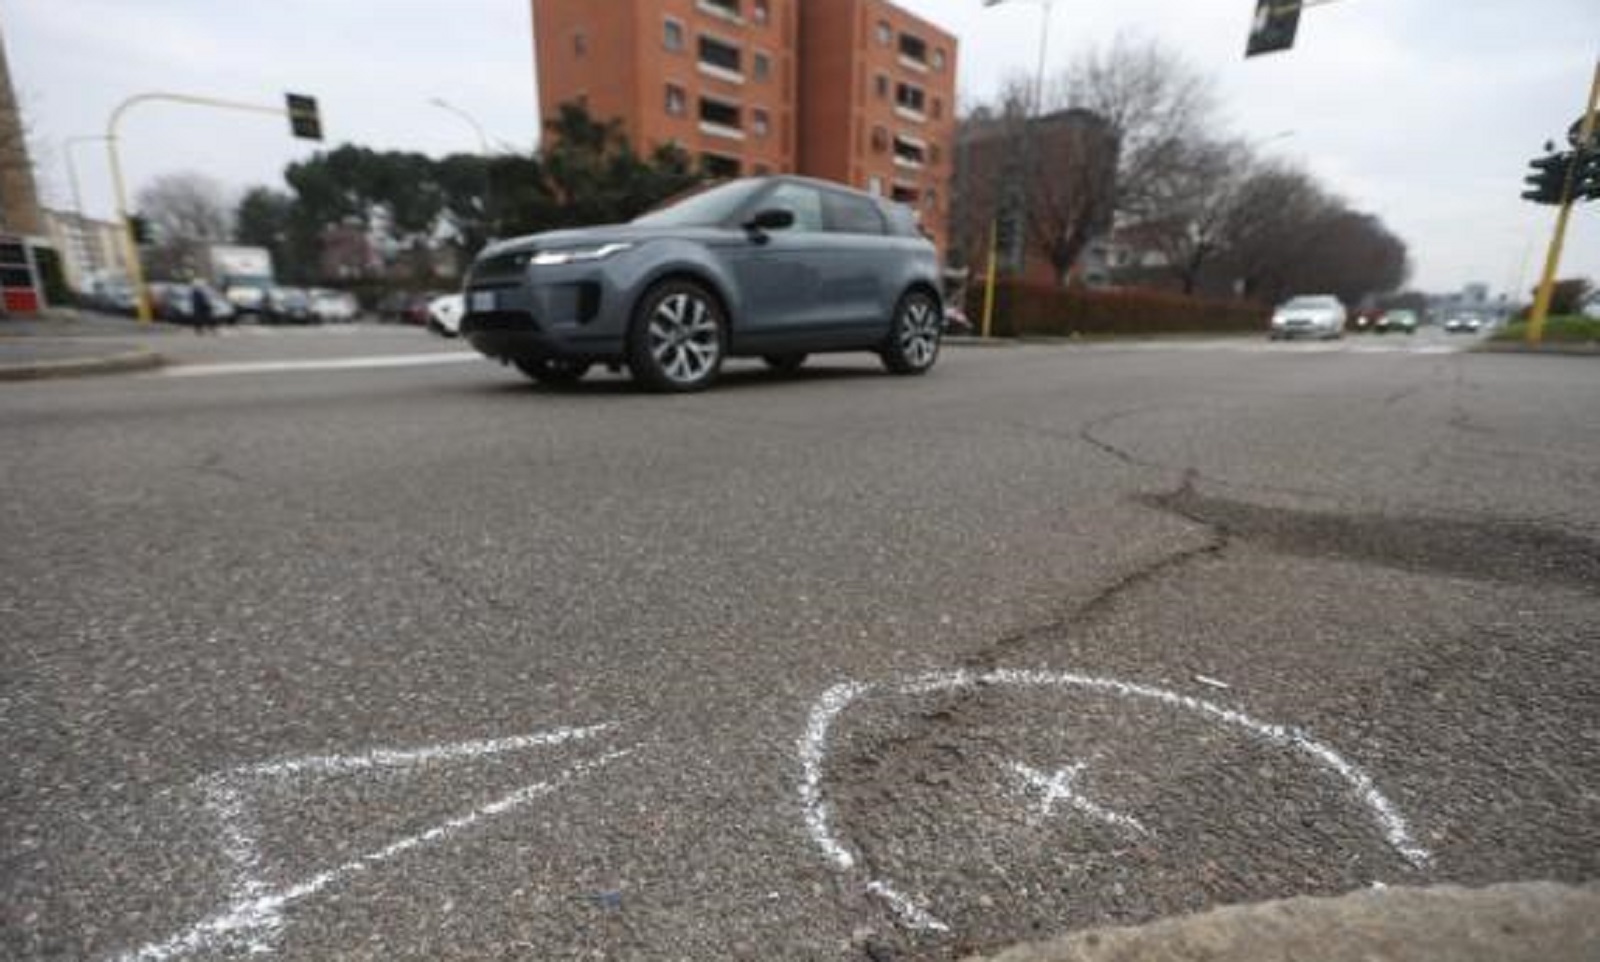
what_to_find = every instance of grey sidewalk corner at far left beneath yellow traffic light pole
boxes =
[0,312,173,381]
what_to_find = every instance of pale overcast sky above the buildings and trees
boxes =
[0,0,1600,290]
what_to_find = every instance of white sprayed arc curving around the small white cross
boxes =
[800,669,1432,932]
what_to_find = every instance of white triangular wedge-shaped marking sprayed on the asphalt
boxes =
[112,724,635,962]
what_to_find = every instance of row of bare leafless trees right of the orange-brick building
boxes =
[952,38,1410,306]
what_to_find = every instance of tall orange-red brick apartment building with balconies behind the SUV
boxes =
[533,0,957,250]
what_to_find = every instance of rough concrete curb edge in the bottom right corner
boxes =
[968,882,1600,962]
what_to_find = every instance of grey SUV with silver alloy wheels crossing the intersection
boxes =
[461,176,944,391]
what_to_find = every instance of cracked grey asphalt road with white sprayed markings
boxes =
[0,328,1600,962]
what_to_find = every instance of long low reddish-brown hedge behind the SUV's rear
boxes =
[966,280,1272,338]
